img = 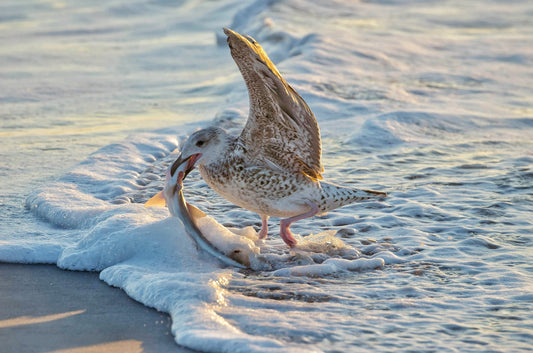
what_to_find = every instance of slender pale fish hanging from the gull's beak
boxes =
[145,164,250,269]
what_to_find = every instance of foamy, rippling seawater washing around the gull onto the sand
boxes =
[0,0,533,352]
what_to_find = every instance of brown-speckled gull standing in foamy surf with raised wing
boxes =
[166,28,387,248]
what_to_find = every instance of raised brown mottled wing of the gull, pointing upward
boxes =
[224,28,323,179]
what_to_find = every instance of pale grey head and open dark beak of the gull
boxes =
[170,127,227,181]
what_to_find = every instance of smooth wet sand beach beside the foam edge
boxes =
[0,263,192,353]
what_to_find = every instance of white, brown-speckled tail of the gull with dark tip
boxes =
[320,181,388,212]
